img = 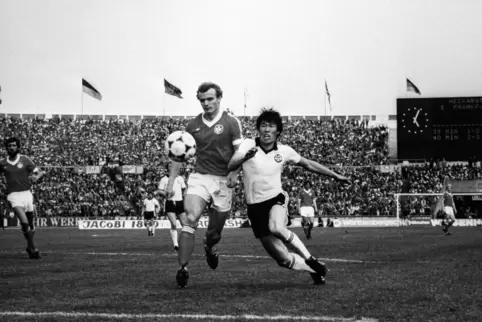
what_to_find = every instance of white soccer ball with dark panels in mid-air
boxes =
[165,131,196,162]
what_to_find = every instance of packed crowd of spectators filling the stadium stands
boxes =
[0,118,482,217]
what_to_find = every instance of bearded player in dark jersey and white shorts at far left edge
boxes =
[0,138,43,259]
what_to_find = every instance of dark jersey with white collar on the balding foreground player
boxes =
[186,111,243,176]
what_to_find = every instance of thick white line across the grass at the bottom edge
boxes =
[0,311,378,322]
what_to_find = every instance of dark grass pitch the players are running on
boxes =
[0,226,482,321]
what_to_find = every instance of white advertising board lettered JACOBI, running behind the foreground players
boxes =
[78,219,246,230]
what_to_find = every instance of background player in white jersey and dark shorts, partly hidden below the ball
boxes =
[158,163,186,252]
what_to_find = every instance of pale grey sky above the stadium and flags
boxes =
[0,0,482,117]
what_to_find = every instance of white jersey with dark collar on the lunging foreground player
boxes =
[239,139,301,204]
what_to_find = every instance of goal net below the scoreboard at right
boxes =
[395,192,482,224]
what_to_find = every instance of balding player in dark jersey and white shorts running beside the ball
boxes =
[166,83,242,288]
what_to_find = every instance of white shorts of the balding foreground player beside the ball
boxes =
[186,172,233,212]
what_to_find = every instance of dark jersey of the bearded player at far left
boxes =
[0,154,35,194]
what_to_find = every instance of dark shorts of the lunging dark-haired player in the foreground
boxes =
[248,193,288,238]
